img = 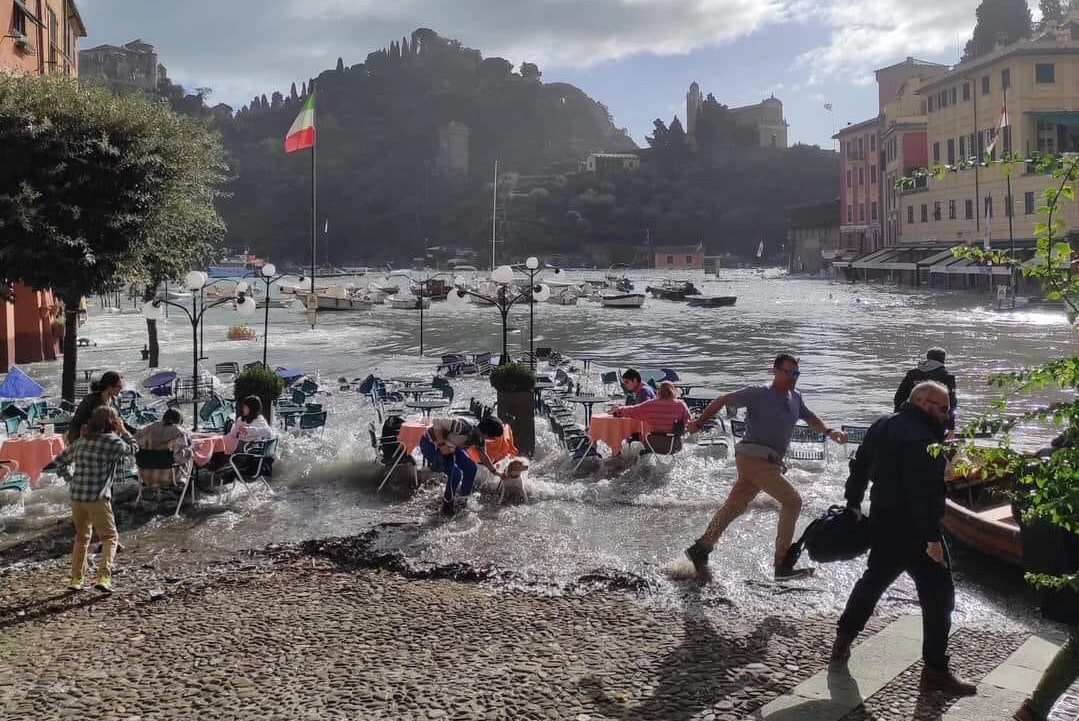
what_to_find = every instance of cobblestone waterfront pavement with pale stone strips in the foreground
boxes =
[0,544,1076,721]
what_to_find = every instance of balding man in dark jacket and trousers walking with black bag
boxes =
[832,381,978,695]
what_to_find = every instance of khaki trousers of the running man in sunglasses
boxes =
[700,453,802,562]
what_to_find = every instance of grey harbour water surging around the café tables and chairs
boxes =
[0,271,1074,621]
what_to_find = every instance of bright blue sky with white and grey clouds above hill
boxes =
[78,0,1037,147]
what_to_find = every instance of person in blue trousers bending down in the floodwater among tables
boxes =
[420,416,505,516]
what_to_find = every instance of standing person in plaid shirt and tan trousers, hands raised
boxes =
[53,406,138,594]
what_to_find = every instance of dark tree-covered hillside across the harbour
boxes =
[157,28,837,266]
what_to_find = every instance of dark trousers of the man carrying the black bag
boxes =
[839,531,955,668]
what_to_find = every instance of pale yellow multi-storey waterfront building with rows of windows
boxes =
[896,28,1079,252]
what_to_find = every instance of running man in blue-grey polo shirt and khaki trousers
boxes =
[685,353,847,581]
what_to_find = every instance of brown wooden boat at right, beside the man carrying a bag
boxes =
[944,476,1023,568]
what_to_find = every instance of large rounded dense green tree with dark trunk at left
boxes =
[0,76,227,399]
